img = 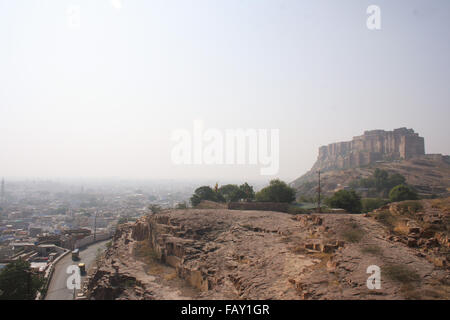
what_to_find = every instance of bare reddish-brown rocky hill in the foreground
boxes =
[88,200,450,299]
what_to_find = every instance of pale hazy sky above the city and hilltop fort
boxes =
[0,0,450,181]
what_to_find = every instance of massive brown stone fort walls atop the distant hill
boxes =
[313,128,425,170]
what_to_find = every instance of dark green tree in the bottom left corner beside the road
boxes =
[0,259,44,300]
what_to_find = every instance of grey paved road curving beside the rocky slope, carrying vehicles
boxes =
[45,240,109,300]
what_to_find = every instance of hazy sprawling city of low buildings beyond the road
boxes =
[0,178,232,273]
